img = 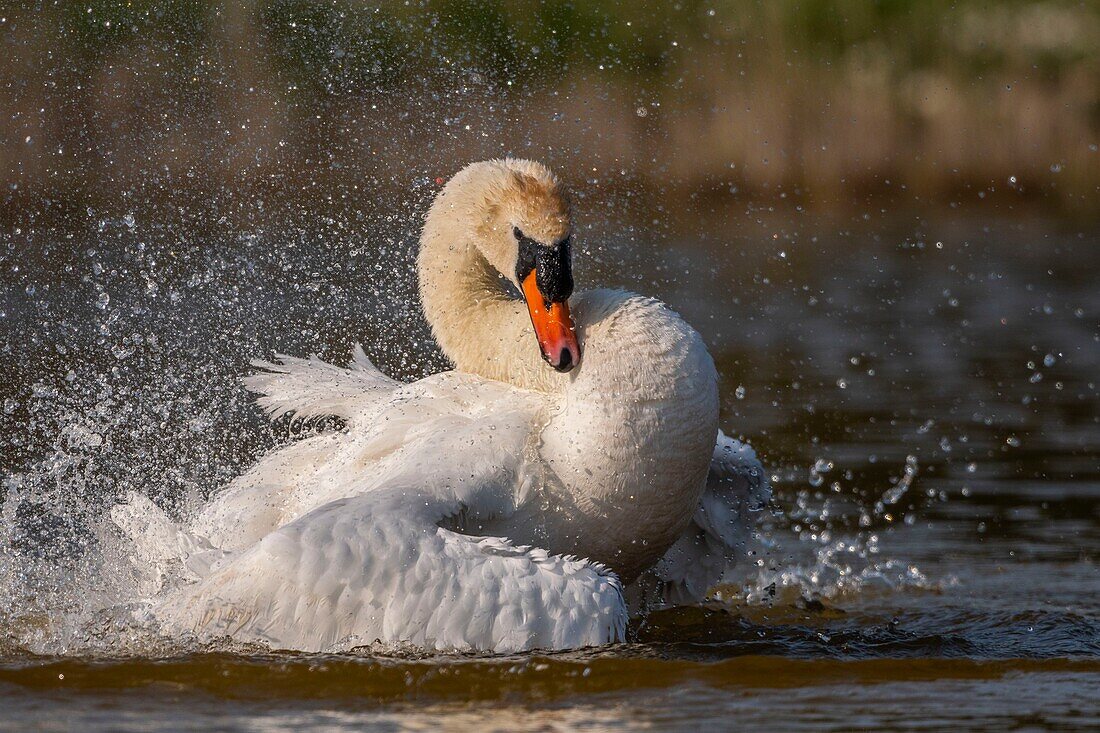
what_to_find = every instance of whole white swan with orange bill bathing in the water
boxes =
[112,158,769,653]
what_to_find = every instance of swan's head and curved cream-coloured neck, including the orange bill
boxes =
[419,158,581,383]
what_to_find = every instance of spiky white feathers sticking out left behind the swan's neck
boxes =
[244,344,399,420]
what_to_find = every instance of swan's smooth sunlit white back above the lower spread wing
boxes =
[190,360,546,550]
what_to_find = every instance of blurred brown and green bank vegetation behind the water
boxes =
[0,0,1100,224]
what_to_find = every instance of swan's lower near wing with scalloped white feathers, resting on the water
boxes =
[155,484,626,653]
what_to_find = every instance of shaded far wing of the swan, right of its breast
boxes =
[652,430,771,603]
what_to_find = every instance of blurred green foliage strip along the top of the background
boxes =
[15,0,1100,92]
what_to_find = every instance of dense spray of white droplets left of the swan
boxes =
[0,214,439,653]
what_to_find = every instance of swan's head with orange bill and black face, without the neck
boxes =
[433,158,581,372]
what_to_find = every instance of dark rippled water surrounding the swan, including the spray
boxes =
[0,208,1100,731]
